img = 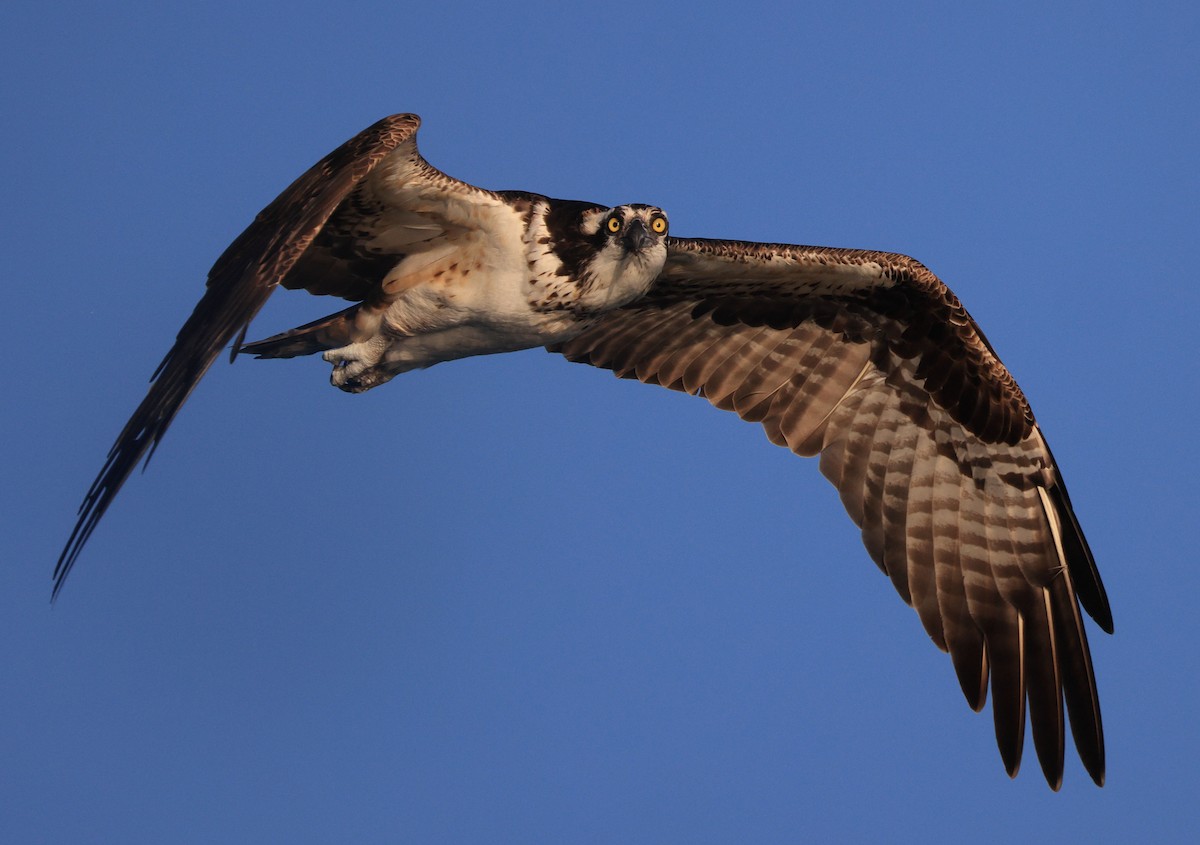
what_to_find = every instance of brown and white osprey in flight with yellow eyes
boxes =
[54,114,1112,789]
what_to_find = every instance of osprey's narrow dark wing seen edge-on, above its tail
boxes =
[54,114,494,595]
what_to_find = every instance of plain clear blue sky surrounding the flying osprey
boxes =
[0,0,1200,843]
